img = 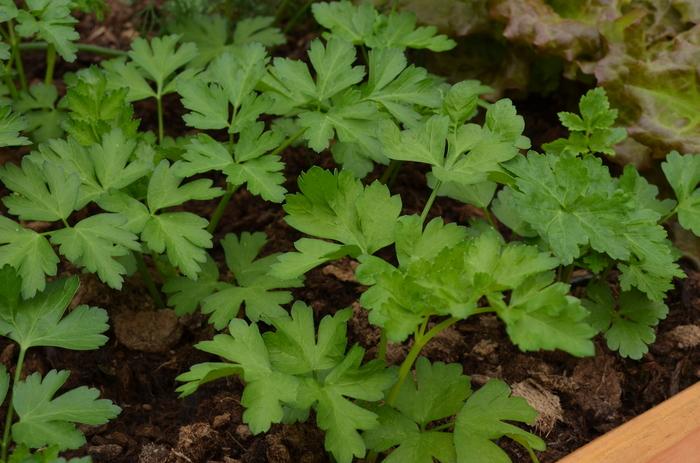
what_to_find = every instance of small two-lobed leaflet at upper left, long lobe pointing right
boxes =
[146,160,223,214]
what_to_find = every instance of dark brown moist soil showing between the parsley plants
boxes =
[0,3,700,463]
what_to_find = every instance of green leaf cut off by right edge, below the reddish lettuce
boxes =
[661,151,700,236]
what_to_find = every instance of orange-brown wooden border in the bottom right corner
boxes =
[559,383,700,463]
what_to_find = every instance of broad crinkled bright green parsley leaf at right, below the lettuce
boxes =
[495,153,682,300]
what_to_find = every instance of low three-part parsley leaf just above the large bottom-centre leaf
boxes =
[201,232,302,329]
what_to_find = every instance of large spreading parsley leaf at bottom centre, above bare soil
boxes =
[180,302,394,463]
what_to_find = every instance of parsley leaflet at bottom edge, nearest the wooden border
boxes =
[454,380,545,463]
